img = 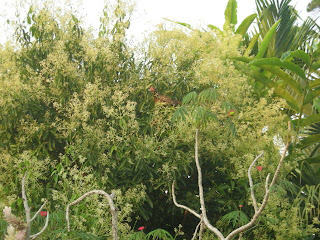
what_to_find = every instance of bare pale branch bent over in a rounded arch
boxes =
[66,190,119,240]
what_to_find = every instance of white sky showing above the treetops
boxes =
[0,0,316,43]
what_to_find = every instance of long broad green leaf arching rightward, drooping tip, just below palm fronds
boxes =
[250,57,306,79]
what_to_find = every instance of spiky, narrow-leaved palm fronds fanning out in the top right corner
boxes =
[252,0,320,57]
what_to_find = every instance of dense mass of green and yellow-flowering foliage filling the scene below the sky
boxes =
[0,0,320,240]
